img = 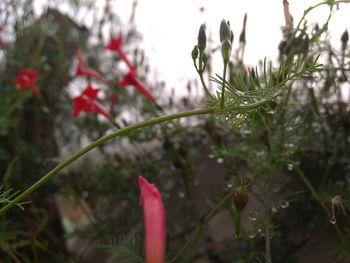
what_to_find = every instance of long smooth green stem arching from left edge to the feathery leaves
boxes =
[0,109,215,215]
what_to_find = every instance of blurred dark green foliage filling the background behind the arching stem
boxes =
[0,0,350,263]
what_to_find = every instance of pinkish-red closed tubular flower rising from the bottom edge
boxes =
[139,176,166,263]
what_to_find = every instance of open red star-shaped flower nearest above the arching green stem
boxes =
[72,85,113,120]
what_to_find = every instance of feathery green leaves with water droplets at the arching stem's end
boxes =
[208,55,321,129]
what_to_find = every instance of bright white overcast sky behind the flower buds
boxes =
[35,0,350,95]
